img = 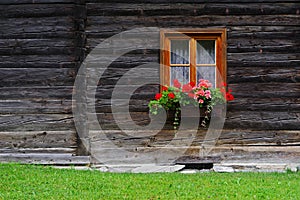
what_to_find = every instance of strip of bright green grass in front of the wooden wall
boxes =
[0,164,300,200]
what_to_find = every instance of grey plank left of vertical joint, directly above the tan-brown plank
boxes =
[0,114,75,132]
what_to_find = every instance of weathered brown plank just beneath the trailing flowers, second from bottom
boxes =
[90,129,300,148]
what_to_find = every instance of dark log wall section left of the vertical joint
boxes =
[0,0,85,156]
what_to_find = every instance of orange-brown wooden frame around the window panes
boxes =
[160,28,227,87]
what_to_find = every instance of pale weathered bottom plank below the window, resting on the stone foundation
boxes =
[93,144,300,165]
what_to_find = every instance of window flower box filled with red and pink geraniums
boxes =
[148,79,234,129]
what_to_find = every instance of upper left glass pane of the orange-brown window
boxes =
[171,40,190,64]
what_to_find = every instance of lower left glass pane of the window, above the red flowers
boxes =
[170,67,190,86]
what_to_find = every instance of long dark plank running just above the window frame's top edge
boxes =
[87,15,300,27]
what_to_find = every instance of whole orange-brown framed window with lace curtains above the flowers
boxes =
[160,28,226,87]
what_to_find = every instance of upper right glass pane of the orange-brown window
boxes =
[197,40,216,64]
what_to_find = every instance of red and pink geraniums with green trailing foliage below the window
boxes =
[148,79,230,129]
